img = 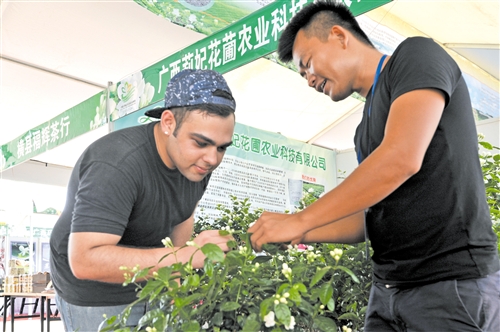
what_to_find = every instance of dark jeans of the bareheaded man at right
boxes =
[365,271,500,332]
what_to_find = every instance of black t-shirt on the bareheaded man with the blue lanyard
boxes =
[355,37,500,284]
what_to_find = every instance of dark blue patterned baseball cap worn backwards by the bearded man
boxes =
[145,69,236,119]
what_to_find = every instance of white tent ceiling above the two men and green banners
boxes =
[0,0,500,182]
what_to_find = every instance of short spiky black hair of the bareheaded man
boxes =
[278,0,374,62]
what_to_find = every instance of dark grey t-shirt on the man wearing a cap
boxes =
[50,123,209,306]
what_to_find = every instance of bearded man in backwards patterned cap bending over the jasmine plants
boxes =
[50,69,236,331]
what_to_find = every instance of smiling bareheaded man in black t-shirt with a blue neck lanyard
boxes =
[249,1,500,331]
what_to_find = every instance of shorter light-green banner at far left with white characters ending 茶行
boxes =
[0,91,106,170]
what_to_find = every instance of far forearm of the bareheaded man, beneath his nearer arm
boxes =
[303,212,365,244]
